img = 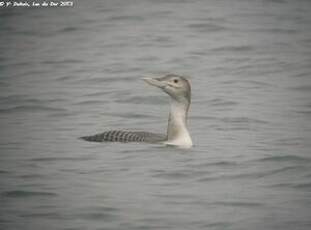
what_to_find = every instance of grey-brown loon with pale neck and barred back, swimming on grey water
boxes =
[81,74,192,148]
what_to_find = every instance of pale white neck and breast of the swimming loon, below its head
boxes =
[165,99,192,147]
